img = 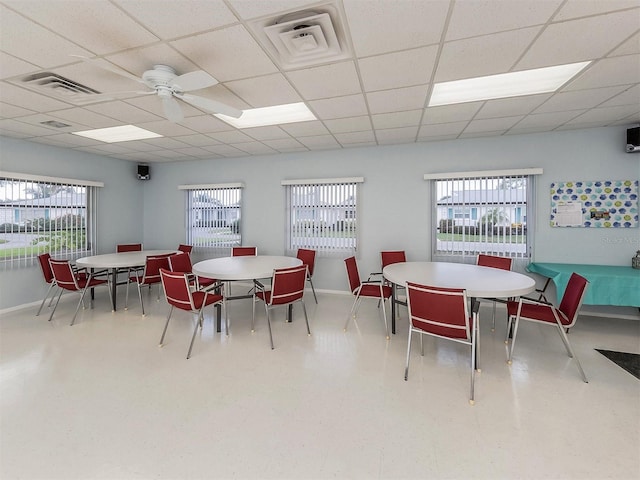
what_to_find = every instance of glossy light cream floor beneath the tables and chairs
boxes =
[0,288,640,480]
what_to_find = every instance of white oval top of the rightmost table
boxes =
[382,262,536,298]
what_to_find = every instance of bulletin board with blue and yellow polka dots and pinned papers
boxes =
[551,180,638,228]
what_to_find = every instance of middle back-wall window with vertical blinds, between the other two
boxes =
[282,177,364,256]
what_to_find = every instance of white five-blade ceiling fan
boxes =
[71,55,242,122]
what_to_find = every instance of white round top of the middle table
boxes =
[193,255,302,280]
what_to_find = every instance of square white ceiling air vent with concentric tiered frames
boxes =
[252,3,351,70]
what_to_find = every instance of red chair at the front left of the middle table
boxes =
[160,268,229,359]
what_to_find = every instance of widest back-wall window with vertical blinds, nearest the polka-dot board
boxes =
[424,168,542,268]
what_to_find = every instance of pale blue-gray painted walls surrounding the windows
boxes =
[0,126,640,314]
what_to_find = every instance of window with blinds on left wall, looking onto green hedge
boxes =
[0,172,103,269]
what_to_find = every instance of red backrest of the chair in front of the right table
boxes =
[407,282,471,339]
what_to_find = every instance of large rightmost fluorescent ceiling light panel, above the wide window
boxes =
[429,62,591,107]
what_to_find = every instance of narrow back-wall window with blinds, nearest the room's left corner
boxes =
[179,183,244,257]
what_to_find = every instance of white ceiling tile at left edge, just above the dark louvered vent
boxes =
[0,2,91,68]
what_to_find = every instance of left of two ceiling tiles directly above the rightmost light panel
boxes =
[435,27,541,82]
